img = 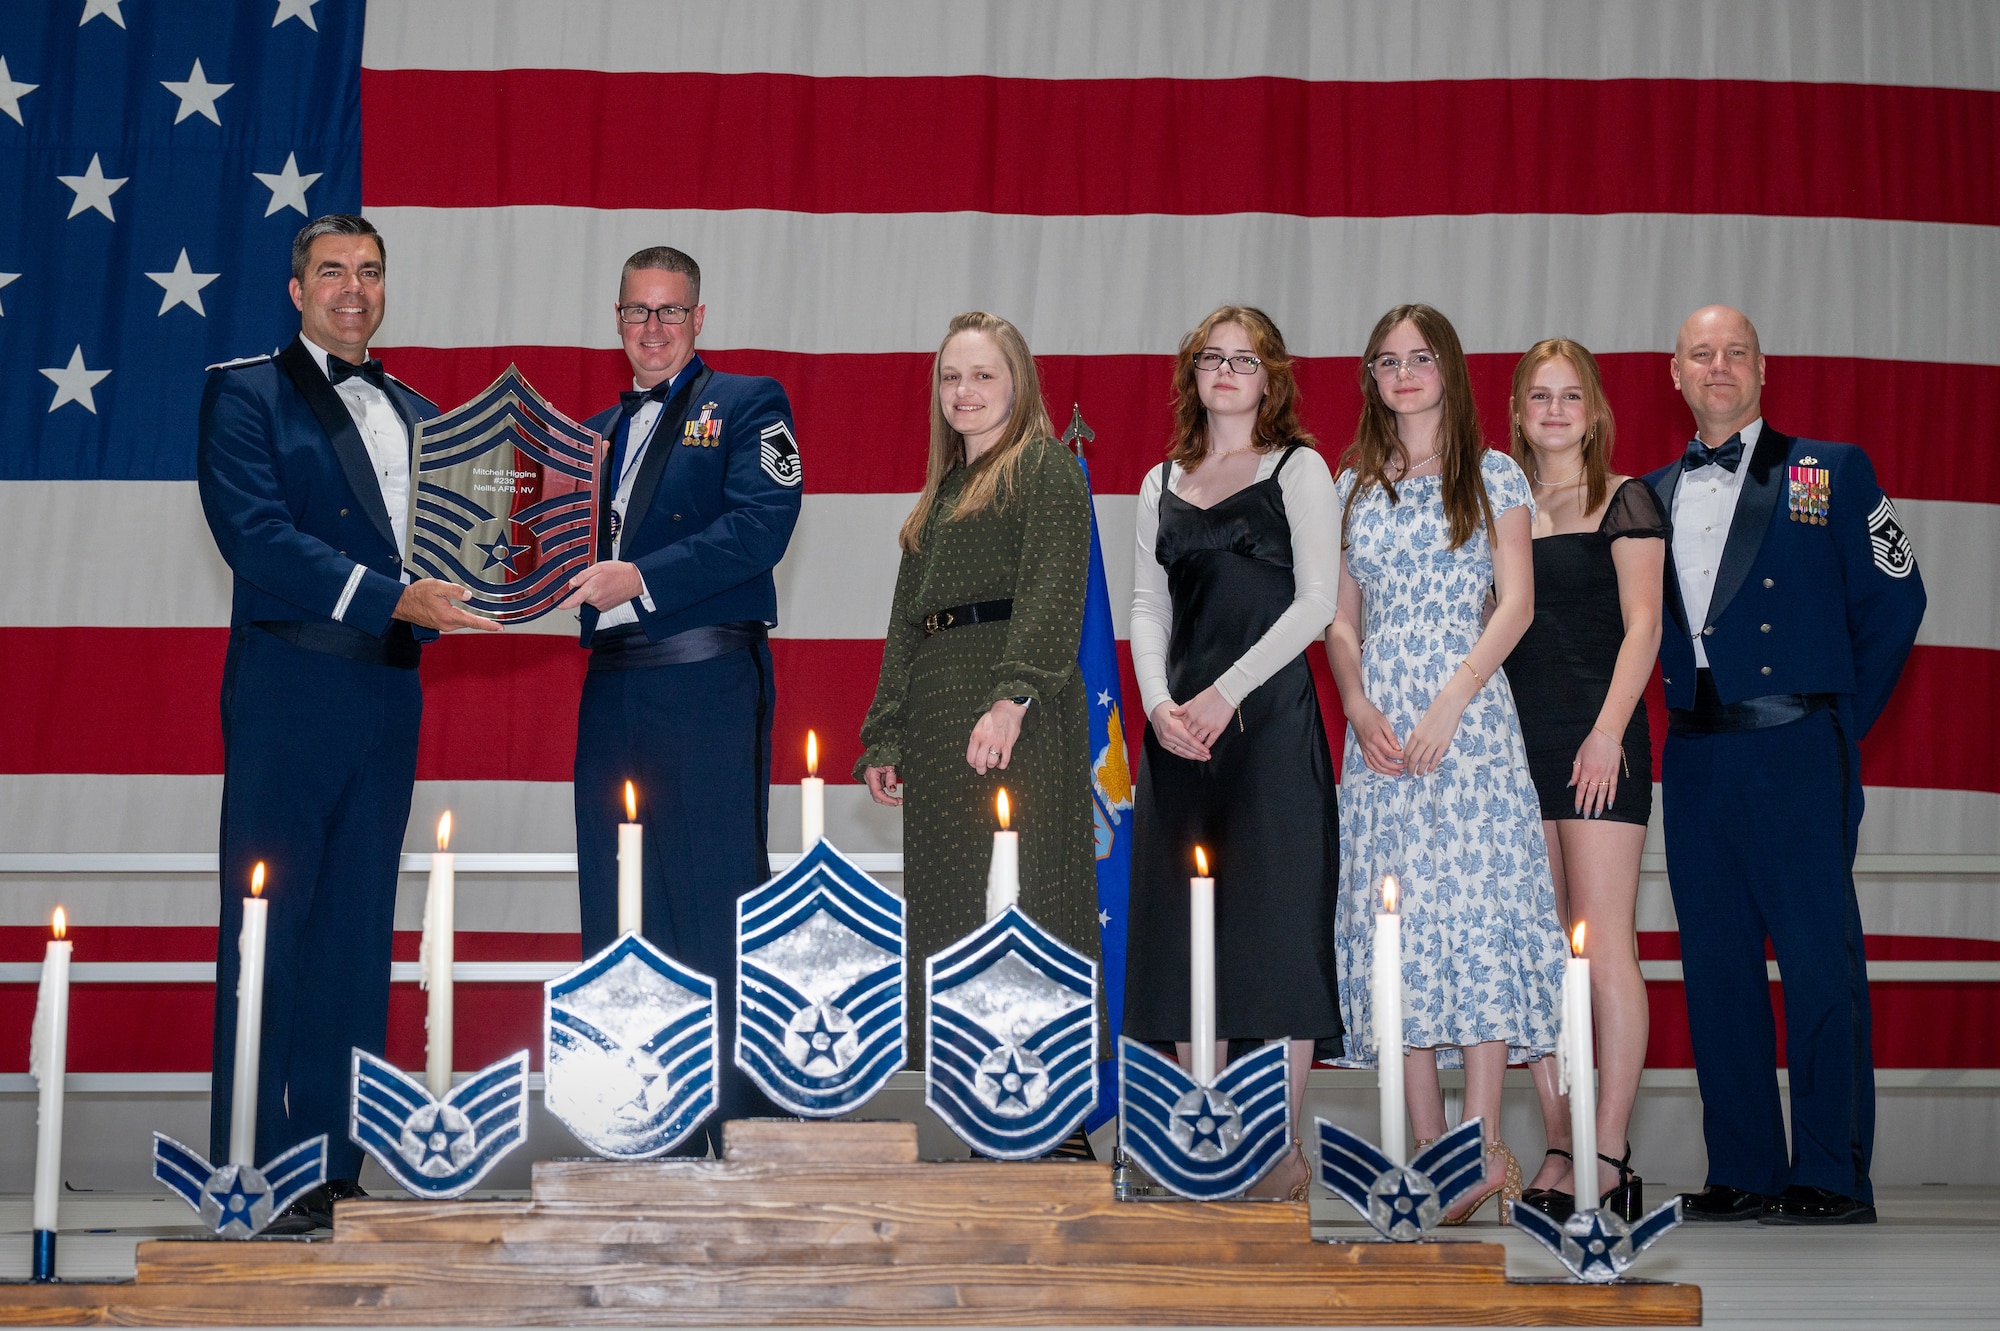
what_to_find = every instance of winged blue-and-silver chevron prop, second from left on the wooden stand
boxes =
[348,1049,528,1201]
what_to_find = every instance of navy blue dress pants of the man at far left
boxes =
[208,628,424,1179]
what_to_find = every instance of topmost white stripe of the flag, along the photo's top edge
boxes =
[362,0,2000,90]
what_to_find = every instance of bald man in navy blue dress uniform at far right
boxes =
[1646,306,1924,1225]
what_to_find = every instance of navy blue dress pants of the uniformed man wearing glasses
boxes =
[576,642,784,1157]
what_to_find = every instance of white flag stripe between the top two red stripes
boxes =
[370,206,2000,364]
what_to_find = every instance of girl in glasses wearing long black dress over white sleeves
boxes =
[1124,306,1340,1199]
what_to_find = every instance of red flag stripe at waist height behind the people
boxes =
[0,628,2000,791]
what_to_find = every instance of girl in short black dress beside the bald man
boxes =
[1506,338,1668,1217]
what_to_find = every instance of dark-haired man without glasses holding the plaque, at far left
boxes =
[196,216,498,1233]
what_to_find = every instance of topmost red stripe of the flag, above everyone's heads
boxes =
[362,70,2000,226]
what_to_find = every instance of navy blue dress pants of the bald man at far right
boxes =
[1660,709,1874,1201]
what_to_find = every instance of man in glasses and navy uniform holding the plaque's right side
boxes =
[564,246,802,1155]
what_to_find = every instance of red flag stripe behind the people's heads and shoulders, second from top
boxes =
[386,343,2000,504]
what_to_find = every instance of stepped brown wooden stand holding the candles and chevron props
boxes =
[0,1123,1702,1327]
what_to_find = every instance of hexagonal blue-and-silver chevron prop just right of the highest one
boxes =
[924,905,1098,1159]
